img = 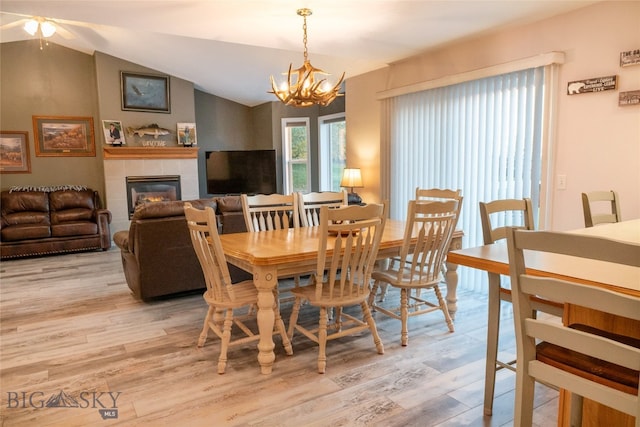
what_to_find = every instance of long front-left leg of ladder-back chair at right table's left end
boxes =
[484,274,500,415]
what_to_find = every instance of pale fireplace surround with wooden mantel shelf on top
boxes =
[104,147,200,237]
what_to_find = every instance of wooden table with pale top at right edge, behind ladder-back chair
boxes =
[447,219,640,426]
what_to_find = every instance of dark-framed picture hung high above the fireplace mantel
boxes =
[120,71,171,113]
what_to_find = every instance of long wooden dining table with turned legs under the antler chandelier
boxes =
[220,220,463,374]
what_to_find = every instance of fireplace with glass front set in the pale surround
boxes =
[126,175,182,219]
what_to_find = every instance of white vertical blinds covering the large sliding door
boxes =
[382,67,546,290]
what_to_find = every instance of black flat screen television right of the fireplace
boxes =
[205,150,277,194]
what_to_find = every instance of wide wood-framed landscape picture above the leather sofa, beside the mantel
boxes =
[33,116,96,157]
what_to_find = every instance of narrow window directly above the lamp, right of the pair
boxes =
[318,113,347,191]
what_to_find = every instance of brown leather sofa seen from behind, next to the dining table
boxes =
[113,196,251,301]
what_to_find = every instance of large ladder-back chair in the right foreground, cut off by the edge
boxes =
[507,229,640,427]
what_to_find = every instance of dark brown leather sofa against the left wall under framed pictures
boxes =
[0,187,111,260]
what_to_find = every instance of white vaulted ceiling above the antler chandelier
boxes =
[0,0,596,106]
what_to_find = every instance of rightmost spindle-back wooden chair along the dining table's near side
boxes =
[369,200,458,346]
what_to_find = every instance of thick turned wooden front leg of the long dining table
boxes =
[253,269,278,374]
